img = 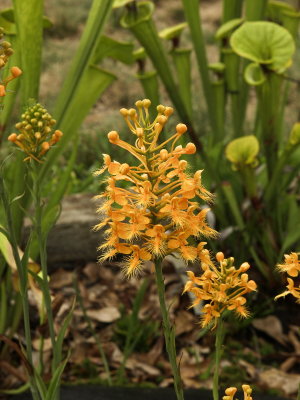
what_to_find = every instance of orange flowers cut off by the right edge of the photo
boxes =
[275,253,300,303]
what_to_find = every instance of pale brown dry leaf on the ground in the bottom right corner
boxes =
[259,368,300,395]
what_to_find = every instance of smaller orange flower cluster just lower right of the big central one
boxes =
[184,250,256,327]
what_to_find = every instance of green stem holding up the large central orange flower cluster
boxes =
[155,259,184,400]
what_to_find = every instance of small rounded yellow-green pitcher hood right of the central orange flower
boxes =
[225,135,259,166]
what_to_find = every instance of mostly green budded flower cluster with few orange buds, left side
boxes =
[8,103,63,163]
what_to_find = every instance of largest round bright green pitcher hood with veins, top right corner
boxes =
[230,21,295,73]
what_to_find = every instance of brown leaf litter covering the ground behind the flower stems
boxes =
[0,261,300,398]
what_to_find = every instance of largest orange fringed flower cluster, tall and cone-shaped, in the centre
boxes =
[95,99,216,276]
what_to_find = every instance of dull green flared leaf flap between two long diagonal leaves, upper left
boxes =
[92,35,134,65]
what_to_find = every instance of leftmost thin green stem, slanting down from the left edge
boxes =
[0,176,40,400]
